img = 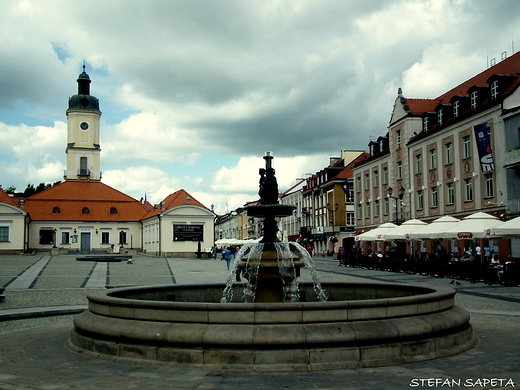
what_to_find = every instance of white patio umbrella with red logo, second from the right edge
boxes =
[442,212,504,240]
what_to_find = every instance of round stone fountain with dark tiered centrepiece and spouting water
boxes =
[69,153,476,371]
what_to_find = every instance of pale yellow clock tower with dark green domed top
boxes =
[64,65,101,181]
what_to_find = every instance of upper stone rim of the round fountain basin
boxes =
[87,282,456,311]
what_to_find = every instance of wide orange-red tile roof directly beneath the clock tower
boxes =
[24,181,147,222]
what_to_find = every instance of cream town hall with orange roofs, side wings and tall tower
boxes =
[0,67,214,257]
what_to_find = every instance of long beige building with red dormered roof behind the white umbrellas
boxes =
[354,53,520,253]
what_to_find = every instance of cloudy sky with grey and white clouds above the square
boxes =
[0,0,520,213]
